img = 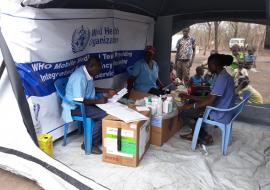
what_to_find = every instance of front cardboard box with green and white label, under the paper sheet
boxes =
[102,112,150,167]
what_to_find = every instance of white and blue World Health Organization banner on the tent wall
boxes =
[0,0,154,138]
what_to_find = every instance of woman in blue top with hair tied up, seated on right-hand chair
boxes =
[179,54,235,144]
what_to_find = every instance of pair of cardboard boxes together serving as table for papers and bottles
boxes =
[102,91,181,167]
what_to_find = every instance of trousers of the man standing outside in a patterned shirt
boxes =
[175,59,191,84]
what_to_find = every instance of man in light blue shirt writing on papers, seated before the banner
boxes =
[62,57,115,154]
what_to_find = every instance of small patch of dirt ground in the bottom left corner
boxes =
[0,169,42,190]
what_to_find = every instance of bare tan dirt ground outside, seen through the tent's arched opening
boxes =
[171,50,270,104]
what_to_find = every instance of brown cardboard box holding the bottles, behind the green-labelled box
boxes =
[129,90,182,146]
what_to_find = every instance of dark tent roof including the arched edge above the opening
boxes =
[30,0,269,33]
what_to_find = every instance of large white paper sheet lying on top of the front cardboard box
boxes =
[97,102,149,123]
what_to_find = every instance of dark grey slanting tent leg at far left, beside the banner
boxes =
[0,28,38,145]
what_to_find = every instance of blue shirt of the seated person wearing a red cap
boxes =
[132,59,159,92]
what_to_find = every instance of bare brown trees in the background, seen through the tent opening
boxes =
[191,21,270,54]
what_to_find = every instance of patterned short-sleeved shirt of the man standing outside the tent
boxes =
[176,37,196,60]
